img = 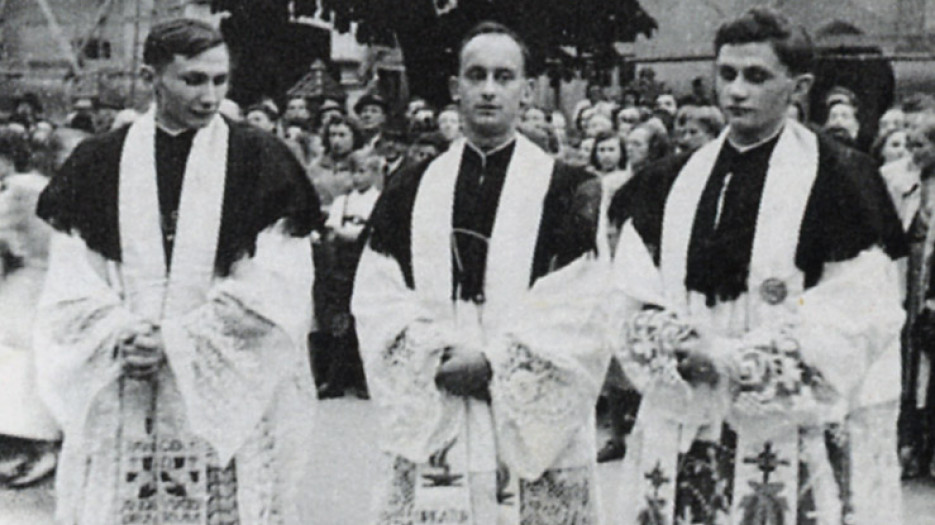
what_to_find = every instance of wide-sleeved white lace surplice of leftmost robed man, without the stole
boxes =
[36,227,315,525]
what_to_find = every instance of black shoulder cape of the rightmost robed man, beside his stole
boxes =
[608,129,908,287]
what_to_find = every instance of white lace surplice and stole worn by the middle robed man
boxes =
[353,138,609,525]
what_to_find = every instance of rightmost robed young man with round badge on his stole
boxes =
[614,8,905,525]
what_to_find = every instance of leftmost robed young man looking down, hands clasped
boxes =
[36,19,321,525]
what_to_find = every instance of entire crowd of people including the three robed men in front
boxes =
[0,8,935,524]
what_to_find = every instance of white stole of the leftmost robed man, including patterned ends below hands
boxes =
[109,107,232,525]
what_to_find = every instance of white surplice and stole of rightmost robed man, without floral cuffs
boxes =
[614,119,903,524]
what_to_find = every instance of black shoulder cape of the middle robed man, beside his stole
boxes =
[367,151,601,289]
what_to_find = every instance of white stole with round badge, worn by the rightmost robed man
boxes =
[644,120,818,523]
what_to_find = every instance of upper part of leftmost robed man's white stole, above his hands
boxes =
[118,108,230,324]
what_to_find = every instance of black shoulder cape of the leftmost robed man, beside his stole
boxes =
[37,117,323,276]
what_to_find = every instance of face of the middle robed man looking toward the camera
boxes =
[452,33,532,146]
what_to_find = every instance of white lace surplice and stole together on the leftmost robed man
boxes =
[36,110,314,525]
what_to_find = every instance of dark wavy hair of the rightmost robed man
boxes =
[714,7,815,75]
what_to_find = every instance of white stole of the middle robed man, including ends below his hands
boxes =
[411,135,555,524]
